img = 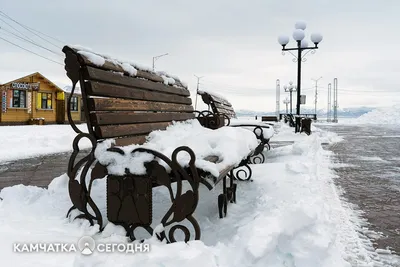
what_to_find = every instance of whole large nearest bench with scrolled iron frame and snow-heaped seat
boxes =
[63,46,263,245]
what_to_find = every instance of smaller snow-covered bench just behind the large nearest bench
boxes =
[197,90,274,163]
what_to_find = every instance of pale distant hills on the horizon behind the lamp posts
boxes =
[236,107,376,118]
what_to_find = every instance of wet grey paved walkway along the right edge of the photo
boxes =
[318,125,400,253]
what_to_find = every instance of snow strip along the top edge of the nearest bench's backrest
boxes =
[68,45,188,88]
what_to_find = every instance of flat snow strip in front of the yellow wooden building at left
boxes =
[0,124,91,162]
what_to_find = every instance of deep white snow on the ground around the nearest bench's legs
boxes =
[0,124,394,267]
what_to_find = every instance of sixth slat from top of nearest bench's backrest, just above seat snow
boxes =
[95,122,172,138]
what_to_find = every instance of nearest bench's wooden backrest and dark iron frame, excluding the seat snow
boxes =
[63,46,261,245]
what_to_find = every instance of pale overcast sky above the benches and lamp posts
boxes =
[0,0,400,111]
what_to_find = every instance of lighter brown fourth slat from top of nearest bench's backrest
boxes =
[87,98,193,112]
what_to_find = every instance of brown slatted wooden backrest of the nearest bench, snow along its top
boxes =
[63,46,195,145]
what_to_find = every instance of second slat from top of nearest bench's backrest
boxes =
[84,66,190,96]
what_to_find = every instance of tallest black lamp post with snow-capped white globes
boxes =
[278,22,322,133]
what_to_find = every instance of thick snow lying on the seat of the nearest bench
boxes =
[95,120,258,180]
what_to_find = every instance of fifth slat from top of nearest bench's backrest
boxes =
[90,111,195,125]
